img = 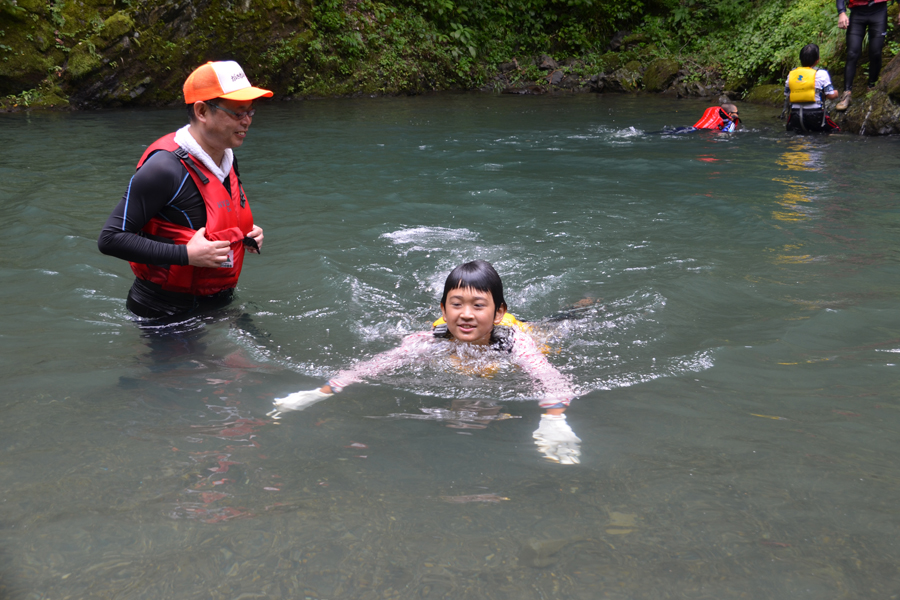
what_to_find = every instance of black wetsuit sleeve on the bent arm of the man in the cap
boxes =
[97,152,206,265]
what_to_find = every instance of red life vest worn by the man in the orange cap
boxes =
[129,133,253,296]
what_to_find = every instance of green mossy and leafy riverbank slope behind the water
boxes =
[0,0,900,109]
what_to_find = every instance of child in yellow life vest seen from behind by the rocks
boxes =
[784,44,840,133]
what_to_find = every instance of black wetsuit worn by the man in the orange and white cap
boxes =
[97,152,233,318]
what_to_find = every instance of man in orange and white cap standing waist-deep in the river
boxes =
[97,61,272,319]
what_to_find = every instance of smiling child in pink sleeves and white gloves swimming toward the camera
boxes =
[270,260,581,464]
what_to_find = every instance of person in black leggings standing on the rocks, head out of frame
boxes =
[834,0,900,111]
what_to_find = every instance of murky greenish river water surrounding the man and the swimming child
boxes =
[0,95,900,600]
